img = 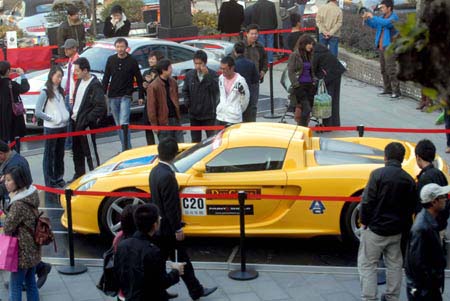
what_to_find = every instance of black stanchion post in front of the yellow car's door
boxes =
[228,191,258,280]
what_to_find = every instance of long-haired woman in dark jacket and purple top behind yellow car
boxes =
[288,34,316,126]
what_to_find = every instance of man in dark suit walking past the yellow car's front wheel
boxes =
[149,137,217,300]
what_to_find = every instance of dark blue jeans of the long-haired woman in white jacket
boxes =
[42,127,67,201]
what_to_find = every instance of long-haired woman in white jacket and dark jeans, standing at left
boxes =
[36,65,69,201]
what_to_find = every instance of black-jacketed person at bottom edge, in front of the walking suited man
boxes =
[114,204,185,301]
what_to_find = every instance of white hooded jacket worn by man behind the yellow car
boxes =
[216,73,250,123]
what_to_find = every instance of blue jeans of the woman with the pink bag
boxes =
[9,267,39,301]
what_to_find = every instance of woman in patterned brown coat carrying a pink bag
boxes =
[4,167,41,301]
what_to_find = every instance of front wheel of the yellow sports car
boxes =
[99,189,149,237]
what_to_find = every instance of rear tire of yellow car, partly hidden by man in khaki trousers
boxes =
[341,202,360,246]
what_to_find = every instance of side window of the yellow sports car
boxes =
[206,147,286,173]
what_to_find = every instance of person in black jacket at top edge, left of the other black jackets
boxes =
[217,0,244,41]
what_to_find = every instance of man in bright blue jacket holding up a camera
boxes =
[360,0,400,99]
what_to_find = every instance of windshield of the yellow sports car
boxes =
[173,136,216,173]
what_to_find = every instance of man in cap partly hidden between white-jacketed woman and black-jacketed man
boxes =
[62,39,80,150]
